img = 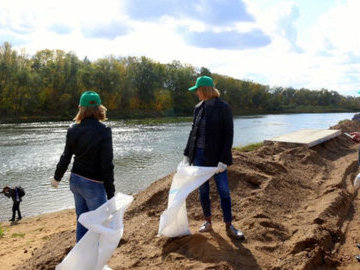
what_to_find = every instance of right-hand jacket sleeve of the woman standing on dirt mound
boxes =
[220,104,234,162]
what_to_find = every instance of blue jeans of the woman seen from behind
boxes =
[70,173,106,242]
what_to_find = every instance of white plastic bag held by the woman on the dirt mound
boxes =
[158,162,217,237]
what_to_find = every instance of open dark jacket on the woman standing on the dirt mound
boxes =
[184,98,234,166]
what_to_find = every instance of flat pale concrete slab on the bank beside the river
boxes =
[264,129,341,148]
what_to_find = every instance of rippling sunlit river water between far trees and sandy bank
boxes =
[0,113,354,221]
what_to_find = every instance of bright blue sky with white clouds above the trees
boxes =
[0,0,360,95]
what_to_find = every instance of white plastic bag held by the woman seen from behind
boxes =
[55,193,134,270]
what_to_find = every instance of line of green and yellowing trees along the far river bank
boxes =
[0,42,360,120]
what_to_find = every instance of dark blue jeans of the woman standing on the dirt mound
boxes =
[194,148,232,222]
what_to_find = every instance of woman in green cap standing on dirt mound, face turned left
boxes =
[184,76,245,240]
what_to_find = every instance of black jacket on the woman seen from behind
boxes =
[54,118,115,199]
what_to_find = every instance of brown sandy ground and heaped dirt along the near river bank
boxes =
[0,120,360,270]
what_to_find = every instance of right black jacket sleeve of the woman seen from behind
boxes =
[100,127,115,200]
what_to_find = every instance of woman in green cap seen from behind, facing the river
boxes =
[50,91,115,242]
